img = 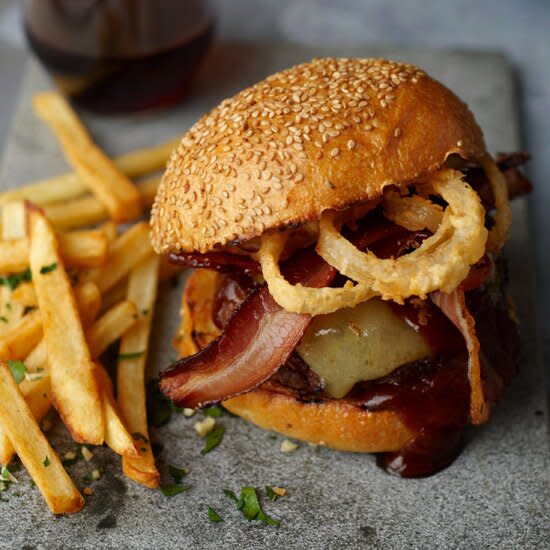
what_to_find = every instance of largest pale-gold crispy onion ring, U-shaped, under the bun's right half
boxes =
[316,169,487,305]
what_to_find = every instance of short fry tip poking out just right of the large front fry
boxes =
[95,363,139,457]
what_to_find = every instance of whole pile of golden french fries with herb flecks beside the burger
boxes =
[0,92,183,514]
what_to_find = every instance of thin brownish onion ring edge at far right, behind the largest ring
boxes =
[479,154,512,252]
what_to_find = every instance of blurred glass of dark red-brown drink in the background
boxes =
[24,0,213,114]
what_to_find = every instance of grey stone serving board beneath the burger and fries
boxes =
[0,44,550,549]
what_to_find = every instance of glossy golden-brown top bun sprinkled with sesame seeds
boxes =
[151,58,485,254]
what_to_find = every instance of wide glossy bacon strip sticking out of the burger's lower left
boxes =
[160,251,336,408]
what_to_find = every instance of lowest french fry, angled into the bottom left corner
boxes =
[0,363,84,514]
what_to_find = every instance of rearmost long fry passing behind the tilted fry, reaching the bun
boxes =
[0,137,181,206]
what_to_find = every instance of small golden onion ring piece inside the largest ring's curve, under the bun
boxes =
[382,189,443,233]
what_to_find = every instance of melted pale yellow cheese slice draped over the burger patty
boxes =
[297,299,431,398]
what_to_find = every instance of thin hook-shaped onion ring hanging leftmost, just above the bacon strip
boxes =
[259,232,374,315]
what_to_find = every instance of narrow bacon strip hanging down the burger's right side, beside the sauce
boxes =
[430,285,502,424]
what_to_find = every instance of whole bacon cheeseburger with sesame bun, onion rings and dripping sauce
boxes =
[151,58,529,477]
